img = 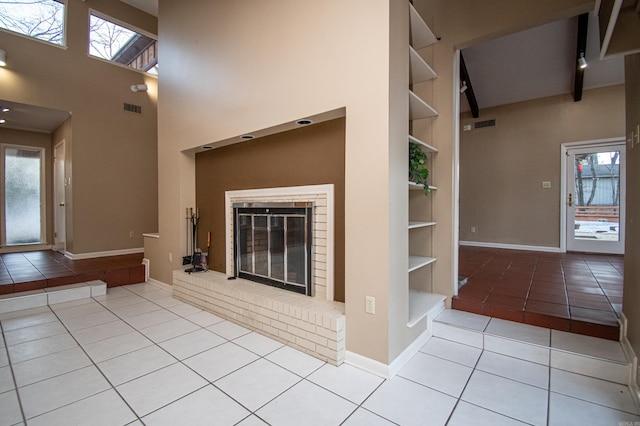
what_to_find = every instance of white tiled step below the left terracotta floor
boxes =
[0,280,107,314]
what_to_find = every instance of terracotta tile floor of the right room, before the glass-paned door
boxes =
[452,246,624,340]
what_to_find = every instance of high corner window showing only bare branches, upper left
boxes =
[0,0,65,46]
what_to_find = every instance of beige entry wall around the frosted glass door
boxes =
[0,127,53,244]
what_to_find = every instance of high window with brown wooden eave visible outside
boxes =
[89,13,158,74]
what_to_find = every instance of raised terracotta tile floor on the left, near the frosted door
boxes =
[0,250,145,294]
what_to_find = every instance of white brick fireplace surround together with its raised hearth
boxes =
[173,185,346,365]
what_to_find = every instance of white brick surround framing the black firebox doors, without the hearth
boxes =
[225,185,334,301]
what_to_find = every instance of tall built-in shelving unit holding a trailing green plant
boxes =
[407,0,445,327]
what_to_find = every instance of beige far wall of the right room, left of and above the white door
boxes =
[460,85,624,248]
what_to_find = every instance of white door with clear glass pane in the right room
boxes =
[565,141,626,254]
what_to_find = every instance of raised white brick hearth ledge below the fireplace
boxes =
[173,270,345,365]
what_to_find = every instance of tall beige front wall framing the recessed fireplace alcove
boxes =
[153,0,408,363]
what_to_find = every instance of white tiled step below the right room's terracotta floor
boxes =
[433,318,632,385]
